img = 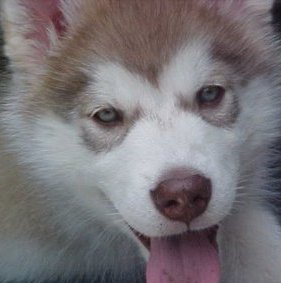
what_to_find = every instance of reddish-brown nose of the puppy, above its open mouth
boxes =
[151,173,212,225]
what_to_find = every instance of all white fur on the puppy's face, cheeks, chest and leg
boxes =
[0,0,281,283]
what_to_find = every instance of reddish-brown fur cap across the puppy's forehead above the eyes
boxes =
[20,0,268,125]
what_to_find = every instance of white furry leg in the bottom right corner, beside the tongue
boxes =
[220,206,281,283]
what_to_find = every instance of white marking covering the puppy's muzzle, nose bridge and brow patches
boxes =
[71,42,241,236]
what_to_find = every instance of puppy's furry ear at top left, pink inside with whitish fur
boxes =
[1,0,81,73]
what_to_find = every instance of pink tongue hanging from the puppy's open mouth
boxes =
[146,233,220,283]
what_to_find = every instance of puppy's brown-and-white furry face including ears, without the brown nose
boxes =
[3,0,275,240]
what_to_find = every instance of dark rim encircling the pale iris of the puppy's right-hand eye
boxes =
[196,84,226,108]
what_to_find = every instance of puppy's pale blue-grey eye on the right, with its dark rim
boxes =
[197,85,225,107]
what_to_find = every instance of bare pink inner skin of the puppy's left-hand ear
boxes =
[22,0,65,47]
